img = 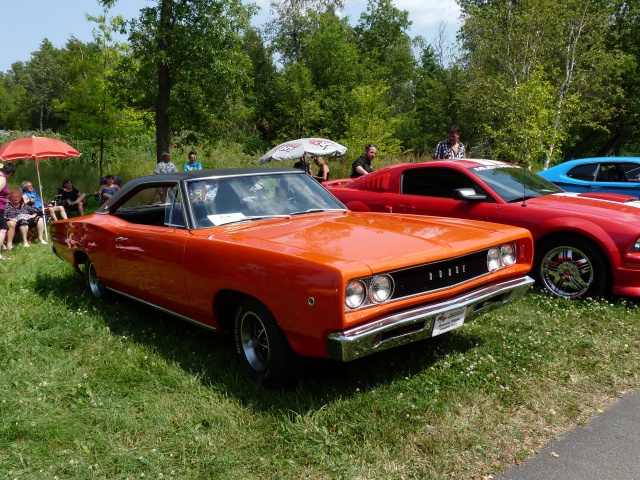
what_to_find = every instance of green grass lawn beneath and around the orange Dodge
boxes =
[0,245,640,479]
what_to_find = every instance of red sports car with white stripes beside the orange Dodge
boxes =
[324,160,640,299]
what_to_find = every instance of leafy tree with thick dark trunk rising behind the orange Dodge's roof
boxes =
[101,0,253,161]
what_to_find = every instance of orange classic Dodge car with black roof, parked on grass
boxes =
[51,168,533,385]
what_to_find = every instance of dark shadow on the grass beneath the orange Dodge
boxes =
[34,271,483,415]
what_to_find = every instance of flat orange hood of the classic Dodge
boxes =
[204,212,529,271]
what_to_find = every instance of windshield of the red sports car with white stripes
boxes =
[470,165,563,202]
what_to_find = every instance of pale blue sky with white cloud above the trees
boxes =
[0,0,460,72]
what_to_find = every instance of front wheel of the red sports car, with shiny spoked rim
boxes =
[533,236,611,300]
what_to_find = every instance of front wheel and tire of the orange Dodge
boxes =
[233,298,302,387]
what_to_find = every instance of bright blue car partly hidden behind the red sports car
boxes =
[538,157,640,197]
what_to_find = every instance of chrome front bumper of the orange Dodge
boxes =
[327,276,533,362]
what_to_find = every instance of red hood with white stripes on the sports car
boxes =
[526,192,640,220]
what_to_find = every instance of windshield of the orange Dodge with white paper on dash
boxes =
[187,172,346,228]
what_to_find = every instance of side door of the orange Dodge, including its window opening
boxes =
[113,185,189,312]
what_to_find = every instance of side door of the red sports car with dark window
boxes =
[392,167,496,221]
